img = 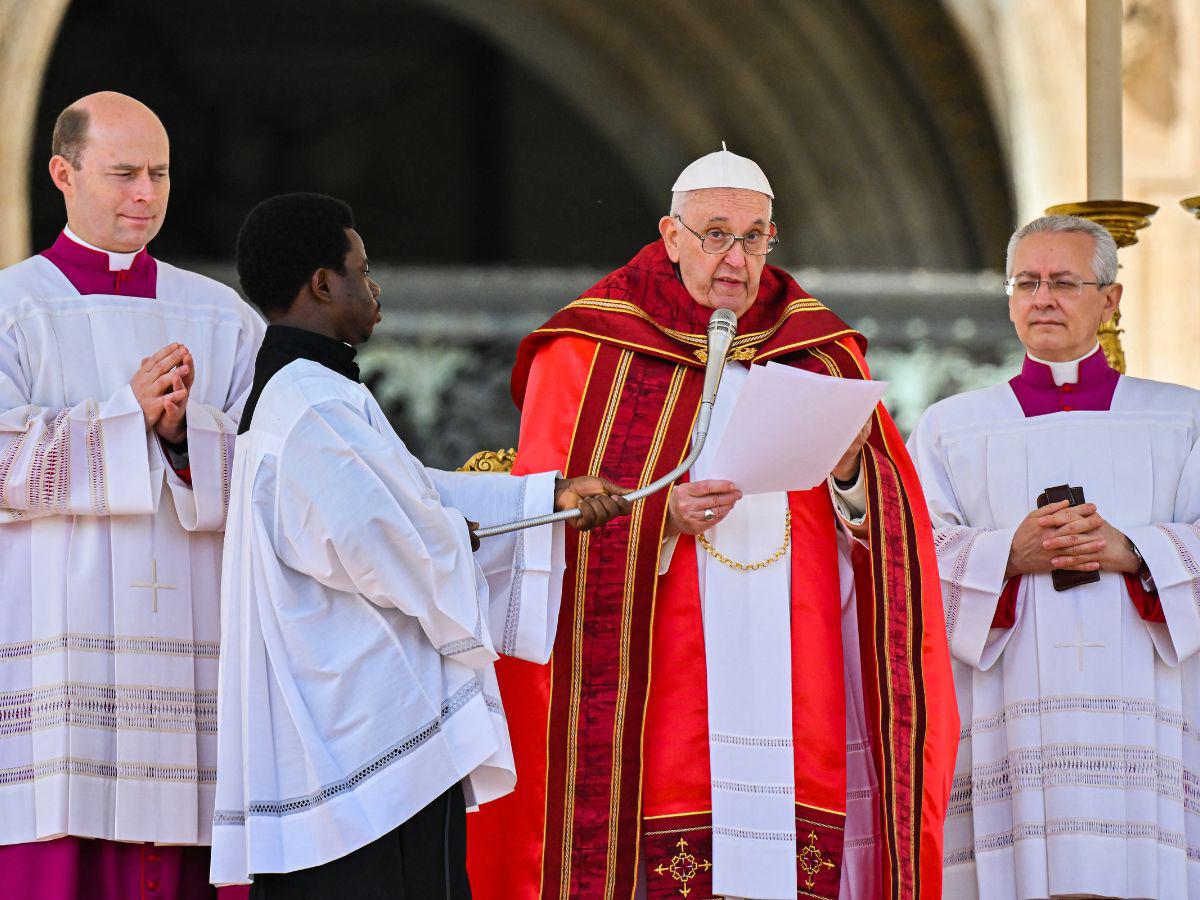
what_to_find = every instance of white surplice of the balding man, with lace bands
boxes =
[0,257,263,844]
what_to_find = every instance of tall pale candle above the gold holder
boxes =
[1087,0,1124,200]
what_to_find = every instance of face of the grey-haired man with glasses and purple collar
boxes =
[1008,232,1121,362]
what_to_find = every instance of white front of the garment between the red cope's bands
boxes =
[691,364,797,899]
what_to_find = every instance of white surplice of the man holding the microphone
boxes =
[211,360,565,883]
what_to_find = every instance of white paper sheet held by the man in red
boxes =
[704,362,888,493]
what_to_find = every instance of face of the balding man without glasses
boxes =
[50,104,170,253]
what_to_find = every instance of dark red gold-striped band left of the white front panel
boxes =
[542,346,701,898]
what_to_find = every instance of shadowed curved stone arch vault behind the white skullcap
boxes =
[420,0,1013,269]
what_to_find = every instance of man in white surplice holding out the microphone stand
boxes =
[212,194,629,900]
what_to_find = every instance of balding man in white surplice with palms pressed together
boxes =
[0,92,263,900]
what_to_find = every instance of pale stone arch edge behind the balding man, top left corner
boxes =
[0,0,70,265]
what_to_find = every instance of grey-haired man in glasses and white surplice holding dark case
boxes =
[910,216,1200,900]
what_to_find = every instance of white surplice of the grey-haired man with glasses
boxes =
[910,377,1200,900]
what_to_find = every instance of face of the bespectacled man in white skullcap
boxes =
[659,187,770,317]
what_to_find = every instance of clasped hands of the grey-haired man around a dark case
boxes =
[1004,500,1140,578]
